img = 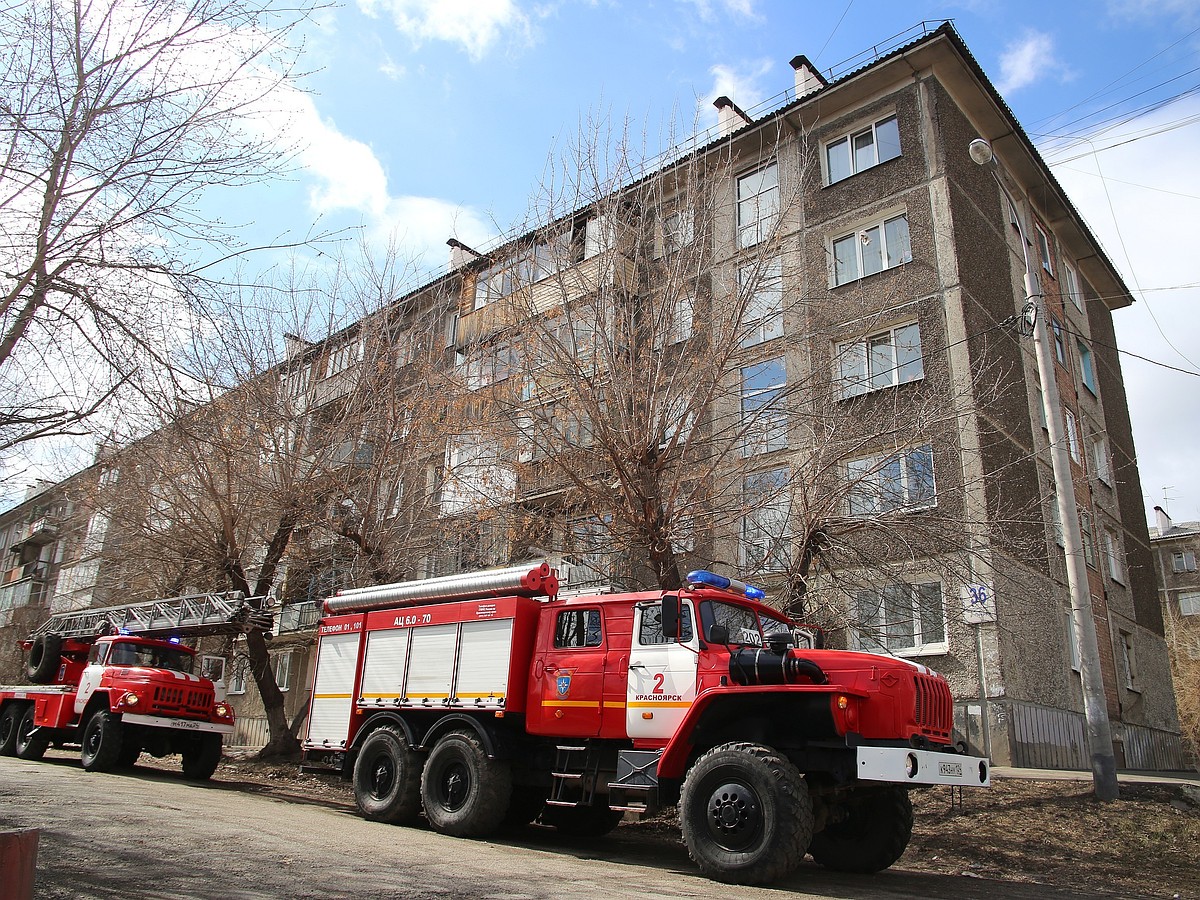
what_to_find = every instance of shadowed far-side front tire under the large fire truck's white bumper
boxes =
[809,786,912,872]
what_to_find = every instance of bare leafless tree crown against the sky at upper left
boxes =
[0,0,312,468]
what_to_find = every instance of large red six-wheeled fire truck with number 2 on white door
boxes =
[304,564,990,883]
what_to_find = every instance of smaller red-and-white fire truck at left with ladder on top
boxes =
[0,592,270,780]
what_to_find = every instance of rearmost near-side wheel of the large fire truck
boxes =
[353,726,422,824]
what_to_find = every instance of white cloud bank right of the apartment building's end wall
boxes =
[1055,98,1200,521]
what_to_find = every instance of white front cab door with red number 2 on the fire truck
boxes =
[625,600,700,740]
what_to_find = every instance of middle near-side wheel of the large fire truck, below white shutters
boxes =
[421,731,512,838]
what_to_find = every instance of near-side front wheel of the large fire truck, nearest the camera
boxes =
[679,743,812,884]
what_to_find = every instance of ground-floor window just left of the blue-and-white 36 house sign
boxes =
[854,581,948,655]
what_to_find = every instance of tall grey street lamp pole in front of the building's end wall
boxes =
[968,138,1118,800]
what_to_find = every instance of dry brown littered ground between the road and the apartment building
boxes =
[162,757,1200,899]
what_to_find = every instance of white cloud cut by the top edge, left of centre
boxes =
[359,0,532,60]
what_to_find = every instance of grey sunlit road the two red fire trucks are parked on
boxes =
[0,757,1092,900]
